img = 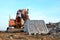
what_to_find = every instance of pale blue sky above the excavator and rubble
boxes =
[0,0,60,30]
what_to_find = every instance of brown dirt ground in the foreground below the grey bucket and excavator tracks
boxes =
[0,32,60,40]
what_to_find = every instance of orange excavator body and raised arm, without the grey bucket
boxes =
[7,9,30,29]
